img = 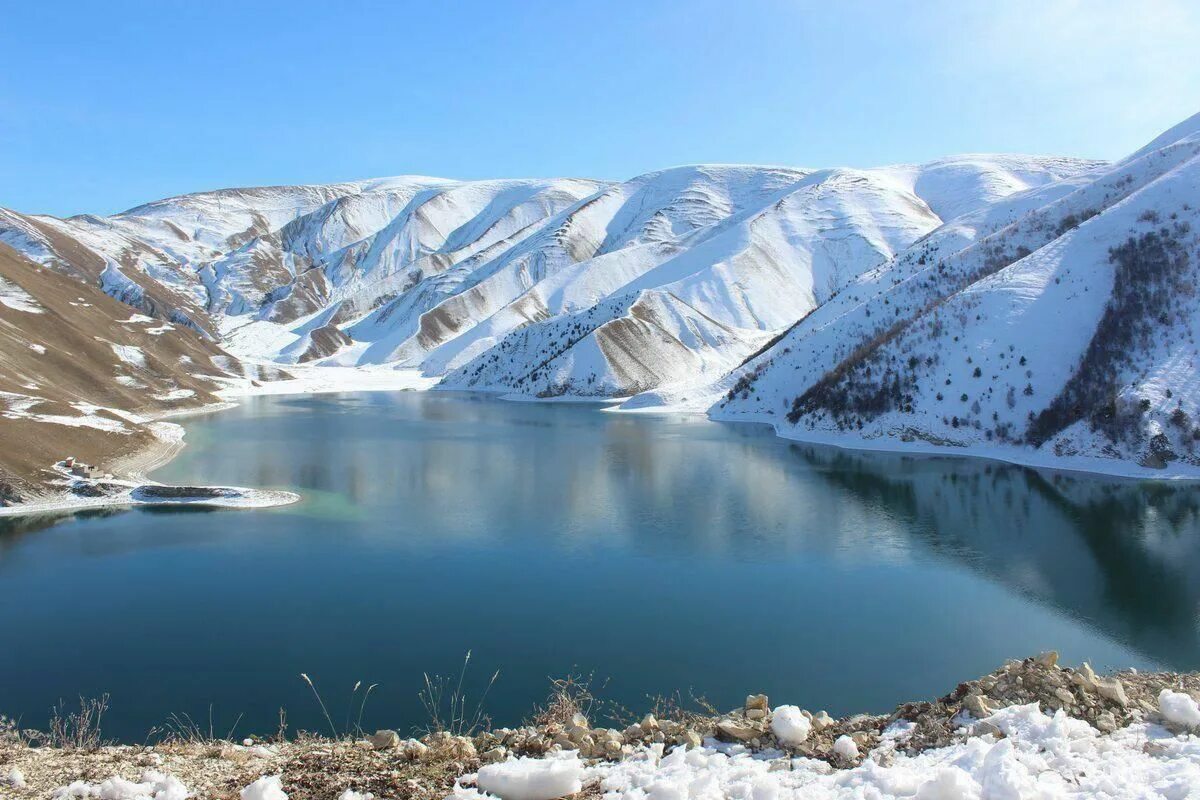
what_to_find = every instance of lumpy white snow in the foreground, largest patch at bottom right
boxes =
[451,694,1200,800]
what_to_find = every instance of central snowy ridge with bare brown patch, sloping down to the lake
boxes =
[436,157,1090,397]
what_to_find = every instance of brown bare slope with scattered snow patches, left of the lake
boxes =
[0,245,235,504]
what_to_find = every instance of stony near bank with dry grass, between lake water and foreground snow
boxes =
[0,652,1200,800]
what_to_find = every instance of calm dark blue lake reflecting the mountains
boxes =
[0,392,1200,741]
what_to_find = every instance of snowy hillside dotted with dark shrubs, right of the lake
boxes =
[710,115,1200,473]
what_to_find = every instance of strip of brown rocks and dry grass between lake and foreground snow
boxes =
[0,654,1200,800]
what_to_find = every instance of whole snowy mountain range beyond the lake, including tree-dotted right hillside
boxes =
[0,108,1200,474]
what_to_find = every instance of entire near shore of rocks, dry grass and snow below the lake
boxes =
[0,652,1200,800]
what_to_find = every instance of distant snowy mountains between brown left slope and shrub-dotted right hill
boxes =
[0,156,1093,397]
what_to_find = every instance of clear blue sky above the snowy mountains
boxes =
[0,0,1200,215]
